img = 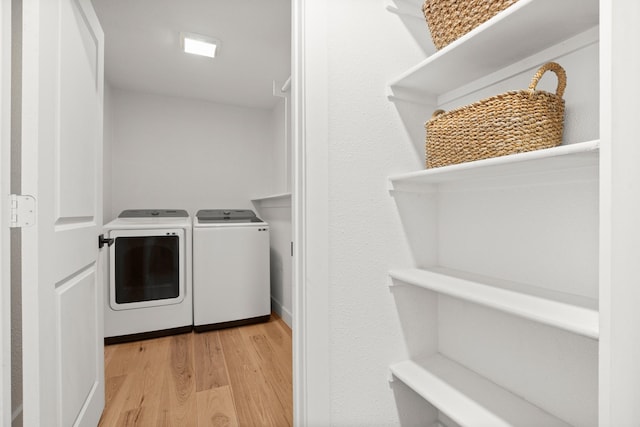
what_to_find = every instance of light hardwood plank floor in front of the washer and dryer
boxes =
[99,315,293,427]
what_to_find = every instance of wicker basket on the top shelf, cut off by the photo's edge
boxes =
[422,0,518,49]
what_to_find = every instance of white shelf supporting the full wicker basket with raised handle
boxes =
[389,140,600,191]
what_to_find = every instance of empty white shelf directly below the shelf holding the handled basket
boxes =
[389,268,600,339]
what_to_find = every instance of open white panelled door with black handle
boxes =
[21,0,104,427]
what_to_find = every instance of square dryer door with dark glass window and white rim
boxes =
[109,228,185,310]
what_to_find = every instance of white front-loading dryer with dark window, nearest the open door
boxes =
[104,209,193,343]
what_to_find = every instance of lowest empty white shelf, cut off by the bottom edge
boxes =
[390,355,569,427]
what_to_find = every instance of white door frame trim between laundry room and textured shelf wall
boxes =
[291,0,331,427]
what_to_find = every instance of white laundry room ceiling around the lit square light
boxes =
[92,0,291,108]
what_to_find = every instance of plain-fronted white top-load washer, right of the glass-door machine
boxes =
[193,209,271,331]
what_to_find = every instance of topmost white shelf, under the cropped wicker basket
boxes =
[390,0,598,95]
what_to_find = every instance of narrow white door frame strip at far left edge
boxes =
[0,1,12,427]
